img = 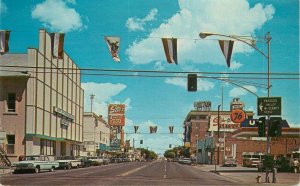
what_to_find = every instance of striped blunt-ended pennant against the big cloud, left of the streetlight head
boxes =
[161,38,178,64]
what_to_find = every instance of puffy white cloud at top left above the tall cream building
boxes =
[31,0,85,32]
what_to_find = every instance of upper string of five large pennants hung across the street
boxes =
[0,30,234,67]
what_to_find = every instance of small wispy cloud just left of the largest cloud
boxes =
[126,8,157,31]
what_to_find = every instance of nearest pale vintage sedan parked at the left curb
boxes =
[11,155,59,173]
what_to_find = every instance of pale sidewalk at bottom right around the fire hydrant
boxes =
[197,165,300,185]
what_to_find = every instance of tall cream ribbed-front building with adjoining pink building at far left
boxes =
[0,30,84,161]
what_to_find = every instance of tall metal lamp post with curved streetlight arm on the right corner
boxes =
[199,32,272,180]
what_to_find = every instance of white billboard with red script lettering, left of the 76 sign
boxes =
[209,114,241,131]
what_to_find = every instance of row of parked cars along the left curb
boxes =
[11,155,110,173]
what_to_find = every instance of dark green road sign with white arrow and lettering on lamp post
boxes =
[257,97,281,116]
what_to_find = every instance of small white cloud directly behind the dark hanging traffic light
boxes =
[165,78,215,91]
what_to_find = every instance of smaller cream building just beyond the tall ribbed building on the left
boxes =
[82,112,110,156]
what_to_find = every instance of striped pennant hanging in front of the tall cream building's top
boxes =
[50,33,65,59]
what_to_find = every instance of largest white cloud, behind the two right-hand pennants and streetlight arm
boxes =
[126,0,275,66]
